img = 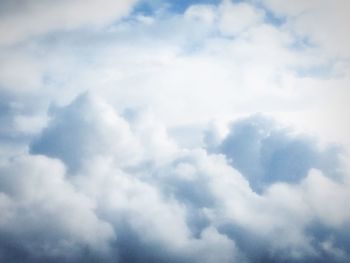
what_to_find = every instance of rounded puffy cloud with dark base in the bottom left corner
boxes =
[0,156,115,262]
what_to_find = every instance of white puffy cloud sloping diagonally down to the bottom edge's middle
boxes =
[74,157,245,262]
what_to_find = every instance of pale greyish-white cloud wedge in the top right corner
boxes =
[263,0,350,59]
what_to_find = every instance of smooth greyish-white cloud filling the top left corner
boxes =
[0,0,136,44]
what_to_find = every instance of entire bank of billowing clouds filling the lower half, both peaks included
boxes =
[0,94,350,262]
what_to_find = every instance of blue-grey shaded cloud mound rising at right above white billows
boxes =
[212,115,339,192]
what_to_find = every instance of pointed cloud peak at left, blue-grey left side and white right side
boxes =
[31,93,142,172]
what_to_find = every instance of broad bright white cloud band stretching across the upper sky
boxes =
[0,2,349,145]
